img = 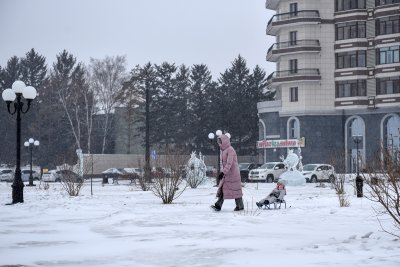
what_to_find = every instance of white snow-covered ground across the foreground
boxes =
[0,181,400,267]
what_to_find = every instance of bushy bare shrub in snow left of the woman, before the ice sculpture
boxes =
[151,149,187,204]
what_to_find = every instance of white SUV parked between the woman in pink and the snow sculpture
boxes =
[249,162,286,183]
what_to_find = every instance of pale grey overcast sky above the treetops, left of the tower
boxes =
[0,0,275,78]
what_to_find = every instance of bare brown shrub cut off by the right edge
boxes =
[363,149,400,237]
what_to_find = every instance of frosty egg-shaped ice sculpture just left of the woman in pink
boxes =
[186,151,206,188]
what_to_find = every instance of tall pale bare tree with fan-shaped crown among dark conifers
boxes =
[90,56,127,154]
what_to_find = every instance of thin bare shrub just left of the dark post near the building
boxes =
[329,151,350,207]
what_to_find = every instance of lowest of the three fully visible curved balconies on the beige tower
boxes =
[267,69,321,86]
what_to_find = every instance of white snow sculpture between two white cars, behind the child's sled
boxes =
[279,149,306,186]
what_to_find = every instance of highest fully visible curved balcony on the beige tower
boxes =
[267,10,321,35]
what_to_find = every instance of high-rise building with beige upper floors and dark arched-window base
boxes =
[258,0,400,172]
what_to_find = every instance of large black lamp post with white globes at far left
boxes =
[2,81,36,204]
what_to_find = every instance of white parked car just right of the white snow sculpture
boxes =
[301,164,336,183]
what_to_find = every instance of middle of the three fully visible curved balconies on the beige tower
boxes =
[267,40,321,62]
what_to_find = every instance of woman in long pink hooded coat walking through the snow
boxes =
[211,134,244,211]
